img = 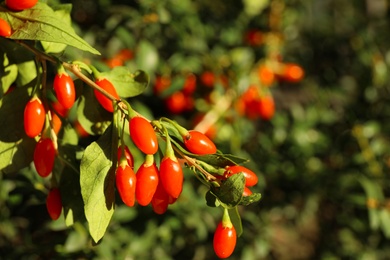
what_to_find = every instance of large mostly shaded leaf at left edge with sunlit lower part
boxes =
[0,87,36,173]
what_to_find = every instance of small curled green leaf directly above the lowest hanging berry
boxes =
[211,173,245,208]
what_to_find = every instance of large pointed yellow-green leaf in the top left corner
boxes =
[0,2,100,55]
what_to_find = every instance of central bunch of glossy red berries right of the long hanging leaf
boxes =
[116,113,217,214]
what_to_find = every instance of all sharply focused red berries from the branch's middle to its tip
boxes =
[116,112,258,258]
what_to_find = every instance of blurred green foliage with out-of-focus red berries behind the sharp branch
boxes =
[0,0,390,259]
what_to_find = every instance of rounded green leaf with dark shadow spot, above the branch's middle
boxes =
[102,66,149,98]
